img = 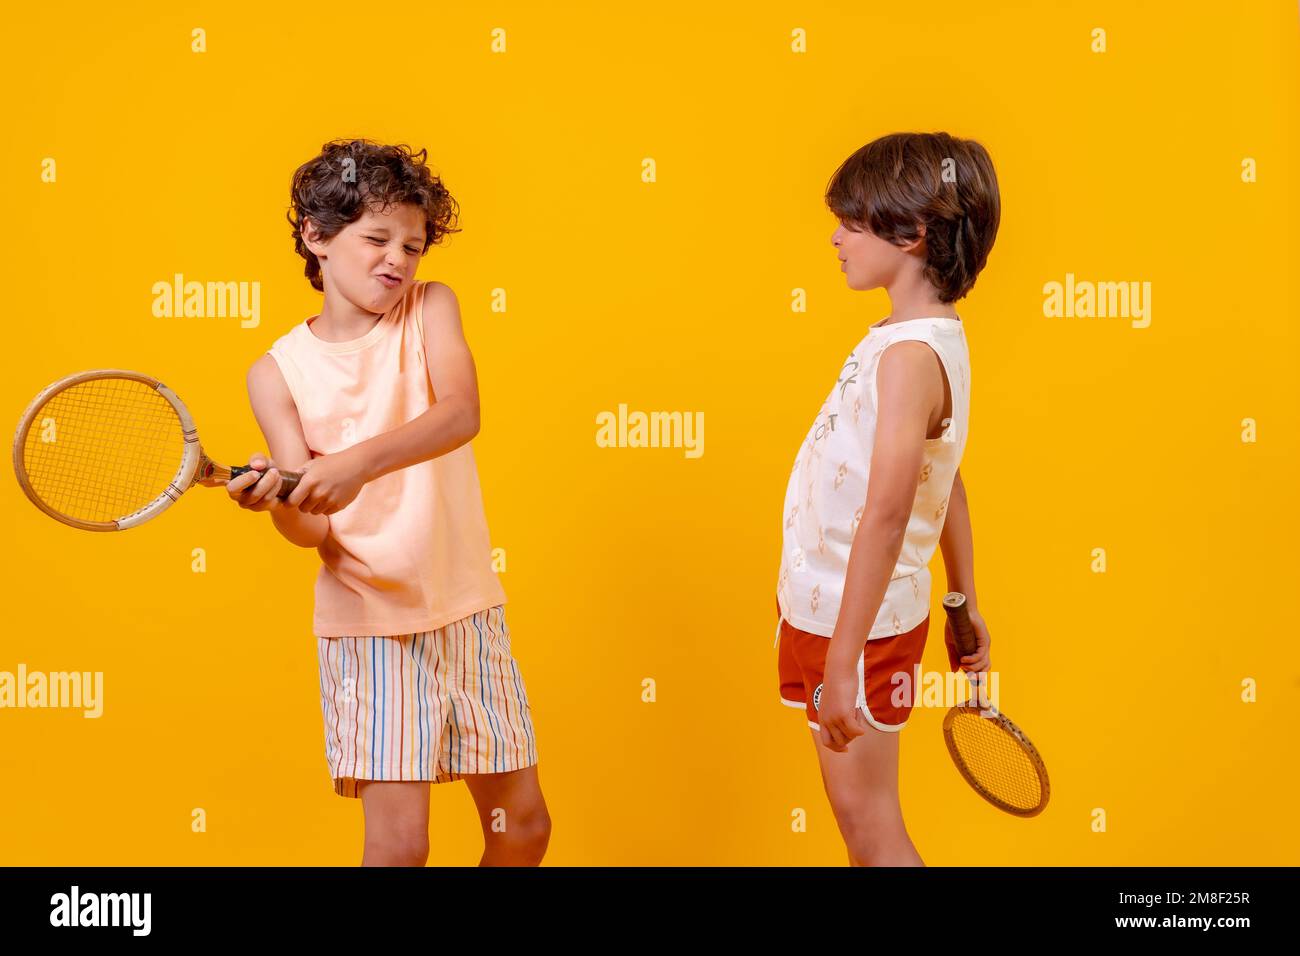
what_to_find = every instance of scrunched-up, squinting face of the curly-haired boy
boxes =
[304,203,425,315]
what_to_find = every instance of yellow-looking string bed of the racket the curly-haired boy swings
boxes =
[22,378,185,522]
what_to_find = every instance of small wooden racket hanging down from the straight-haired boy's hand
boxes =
[944,591,1052,817]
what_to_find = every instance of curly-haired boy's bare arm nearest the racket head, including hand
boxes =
[236,354,329,548]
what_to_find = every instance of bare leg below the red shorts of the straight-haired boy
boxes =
[813,727,926,866]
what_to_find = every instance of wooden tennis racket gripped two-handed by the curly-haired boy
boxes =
[13,368,302,531]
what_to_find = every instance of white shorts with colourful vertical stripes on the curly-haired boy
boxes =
[316,605,537,797]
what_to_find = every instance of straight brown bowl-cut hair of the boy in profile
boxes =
[826,133,1001,302]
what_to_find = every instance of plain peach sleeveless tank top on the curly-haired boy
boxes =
[268,282,506,637]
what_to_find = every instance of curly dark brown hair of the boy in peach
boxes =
[287,139,460,291]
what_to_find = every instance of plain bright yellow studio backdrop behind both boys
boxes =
[0,1,1300,865]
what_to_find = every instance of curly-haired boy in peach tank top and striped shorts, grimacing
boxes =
[228,139,550,866]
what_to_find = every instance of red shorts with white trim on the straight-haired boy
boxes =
[776,605,930,732]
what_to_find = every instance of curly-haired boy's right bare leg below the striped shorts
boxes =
[463,765,551,866]
